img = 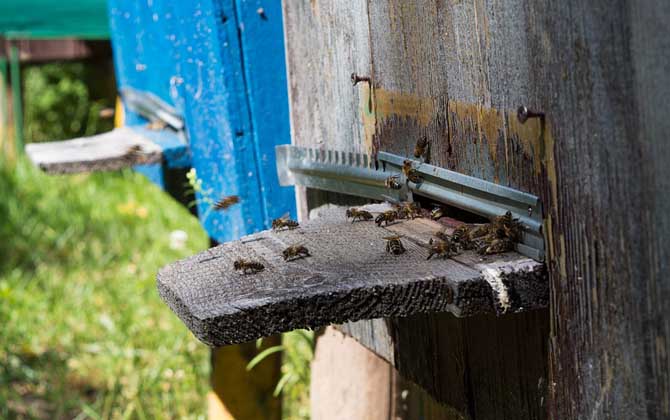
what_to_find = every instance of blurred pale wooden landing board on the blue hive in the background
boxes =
[26,127,162,174]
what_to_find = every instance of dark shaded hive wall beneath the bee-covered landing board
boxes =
[337,309,549,420]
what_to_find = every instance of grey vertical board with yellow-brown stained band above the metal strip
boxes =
[370,0,542,192]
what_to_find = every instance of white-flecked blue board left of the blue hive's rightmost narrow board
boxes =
[174,0,265,242]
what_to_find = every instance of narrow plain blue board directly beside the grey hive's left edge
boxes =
[236,0,295,223]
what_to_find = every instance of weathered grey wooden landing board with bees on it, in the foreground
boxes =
[158,205,549,346]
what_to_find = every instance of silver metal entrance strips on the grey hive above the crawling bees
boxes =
[275,145,544,260]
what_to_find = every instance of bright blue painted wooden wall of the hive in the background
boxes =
[110,0,295,242]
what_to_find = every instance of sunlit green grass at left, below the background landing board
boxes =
[0,158,209,419]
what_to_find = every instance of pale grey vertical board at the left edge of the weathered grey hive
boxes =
[283,0,374,153]
